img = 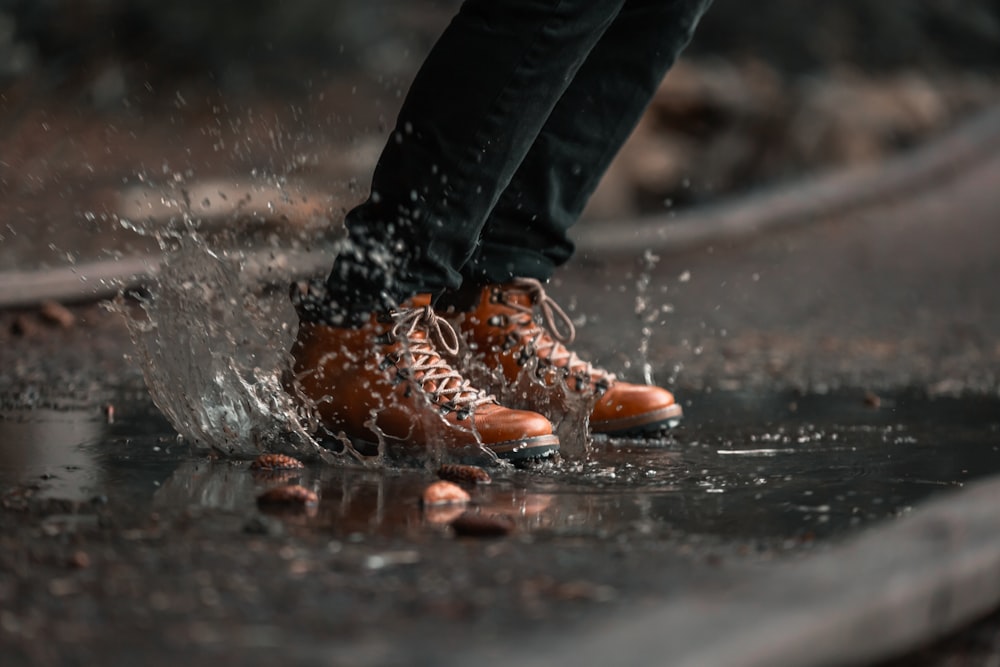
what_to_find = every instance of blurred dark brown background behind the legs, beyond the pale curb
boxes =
[0,0,1000,266]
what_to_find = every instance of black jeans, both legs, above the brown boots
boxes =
[299,0,711,325]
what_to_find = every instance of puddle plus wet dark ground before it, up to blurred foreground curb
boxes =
[0,389,1000,664]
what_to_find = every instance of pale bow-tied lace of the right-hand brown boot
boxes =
[505,278,615,389]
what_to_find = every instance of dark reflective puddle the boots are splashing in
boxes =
[0,392,1000,548]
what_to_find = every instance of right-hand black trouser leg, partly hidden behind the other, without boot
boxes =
[462,0,711,285]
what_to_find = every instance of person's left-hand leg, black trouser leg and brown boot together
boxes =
[289,0,636,459]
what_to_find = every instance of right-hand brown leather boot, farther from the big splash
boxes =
[454,278,683,436]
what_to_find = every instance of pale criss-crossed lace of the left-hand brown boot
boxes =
[390,306,495,418]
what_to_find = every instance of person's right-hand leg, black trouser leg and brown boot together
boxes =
[439,0,709,436]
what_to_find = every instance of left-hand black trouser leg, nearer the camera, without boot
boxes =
[299,0,625,325]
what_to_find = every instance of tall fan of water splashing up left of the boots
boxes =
[118,232,336,460]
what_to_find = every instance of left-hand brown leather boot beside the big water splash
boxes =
[292,296,559,459]
